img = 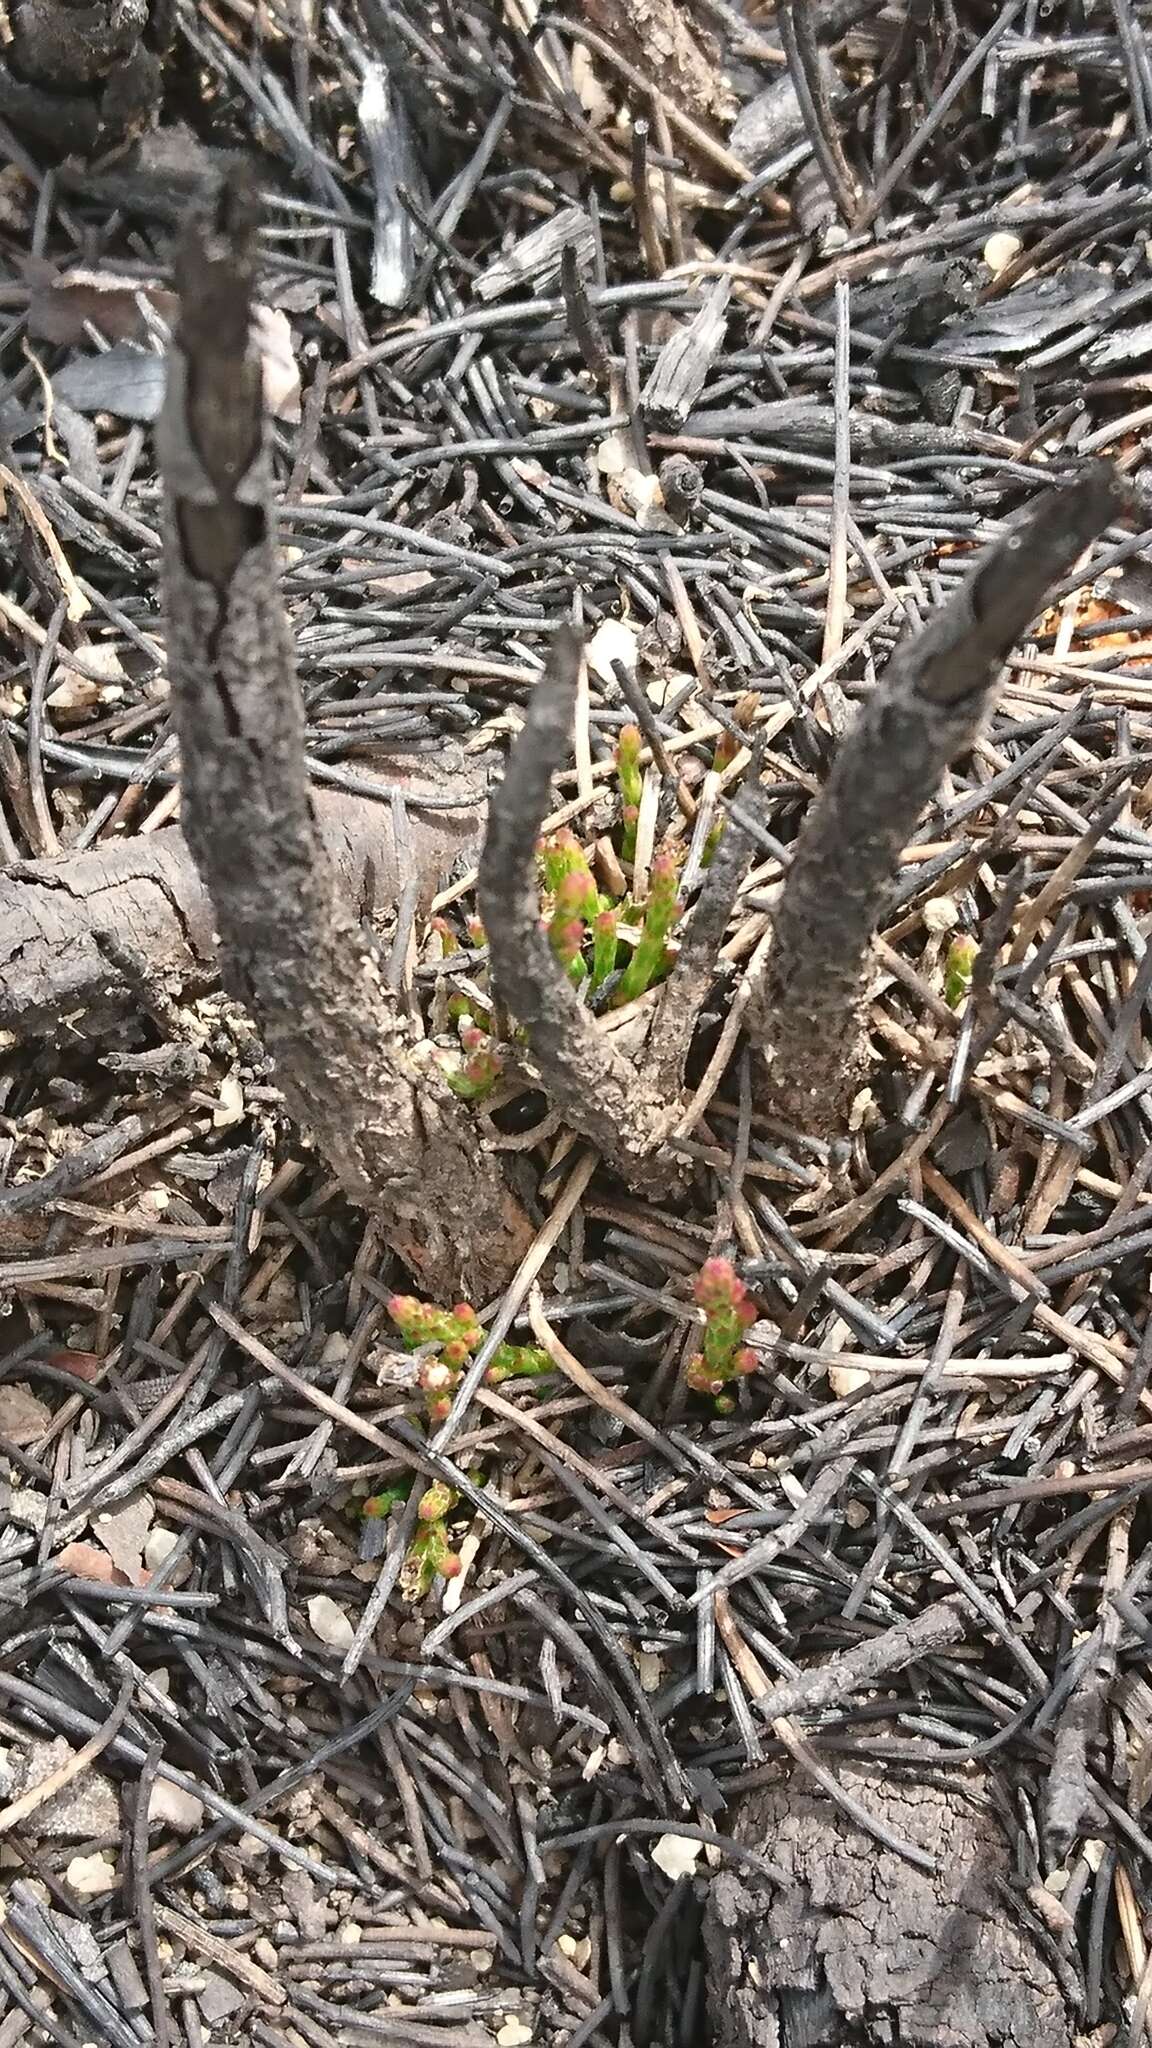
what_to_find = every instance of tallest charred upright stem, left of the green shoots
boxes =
[158,168,531,1298]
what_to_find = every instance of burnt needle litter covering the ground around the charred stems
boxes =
[0,0,1152,2048]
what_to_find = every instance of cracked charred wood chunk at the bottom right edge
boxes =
[705,1759,1074,2048]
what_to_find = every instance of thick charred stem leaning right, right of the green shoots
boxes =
[748,463,1129,1135]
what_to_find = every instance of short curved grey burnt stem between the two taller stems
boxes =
[478,631,676,1188]
